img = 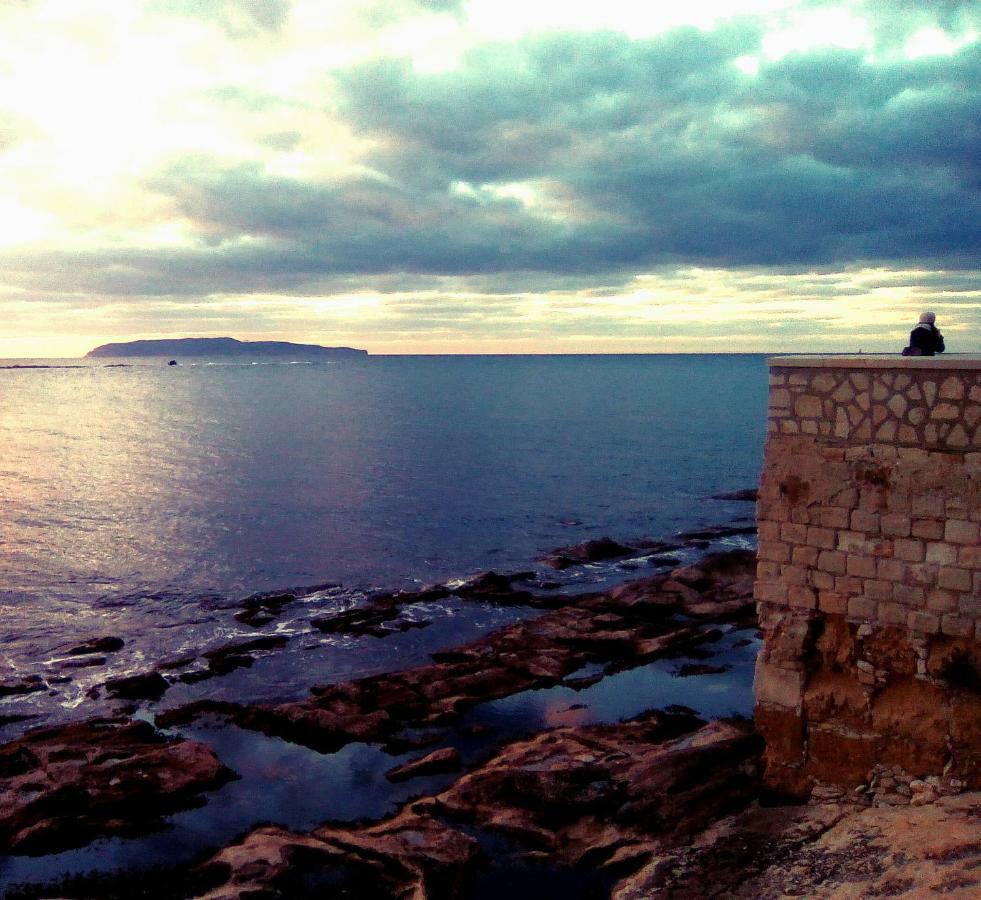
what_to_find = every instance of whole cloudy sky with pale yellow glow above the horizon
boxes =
[0,0,981,357]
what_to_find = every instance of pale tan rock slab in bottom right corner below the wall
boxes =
[612,793,981,900]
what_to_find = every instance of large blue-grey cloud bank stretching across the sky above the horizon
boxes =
[7,21,981,296]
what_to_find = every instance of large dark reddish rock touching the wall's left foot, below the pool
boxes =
[424,712,762,867]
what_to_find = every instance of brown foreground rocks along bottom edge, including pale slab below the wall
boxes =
[191,711,981,900]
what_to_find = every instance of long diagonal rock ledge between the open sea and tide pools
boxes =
[157,551,755,752]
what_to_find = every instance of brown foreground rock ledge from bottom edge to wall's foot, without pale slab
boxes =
[189,712,762,900]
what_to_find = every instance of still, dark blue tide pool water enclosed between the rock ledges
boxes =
[0,626,760,897]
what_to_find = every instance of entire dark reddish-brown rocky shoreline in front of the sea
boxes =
[0,546,981,900]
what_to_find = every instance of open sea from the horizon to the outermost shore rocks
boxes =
[0,355,767,732]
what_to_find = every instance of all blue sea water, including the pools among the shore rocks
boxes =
[0,354,767,890]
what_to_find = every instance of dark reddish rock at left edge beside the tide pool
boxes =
[0,719,233,853]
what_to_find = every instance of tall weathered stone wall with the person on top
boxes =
[756,357,981,795]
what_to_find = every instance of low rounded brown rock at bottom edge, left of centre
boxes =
[199,811,479,900]
